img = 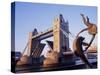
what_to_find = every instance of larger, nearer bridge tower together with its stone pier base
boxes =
[43,14,73,66]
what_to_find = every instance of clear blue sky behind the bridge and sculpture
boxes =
[12,2,97,53]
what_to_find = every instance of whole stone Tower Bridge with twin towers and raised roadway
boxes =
[18,14,73,65]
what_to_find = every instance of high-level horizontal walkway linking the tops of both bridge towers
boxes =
[32,28,53,40]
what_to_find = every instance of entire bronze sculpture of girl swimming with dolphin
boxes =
[73,14,97,68]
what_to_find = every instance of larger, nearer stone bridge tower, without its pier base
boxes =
[53,14,69,53]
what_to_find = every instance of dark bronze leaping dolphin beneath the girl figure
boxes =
[73,36,92,68]
